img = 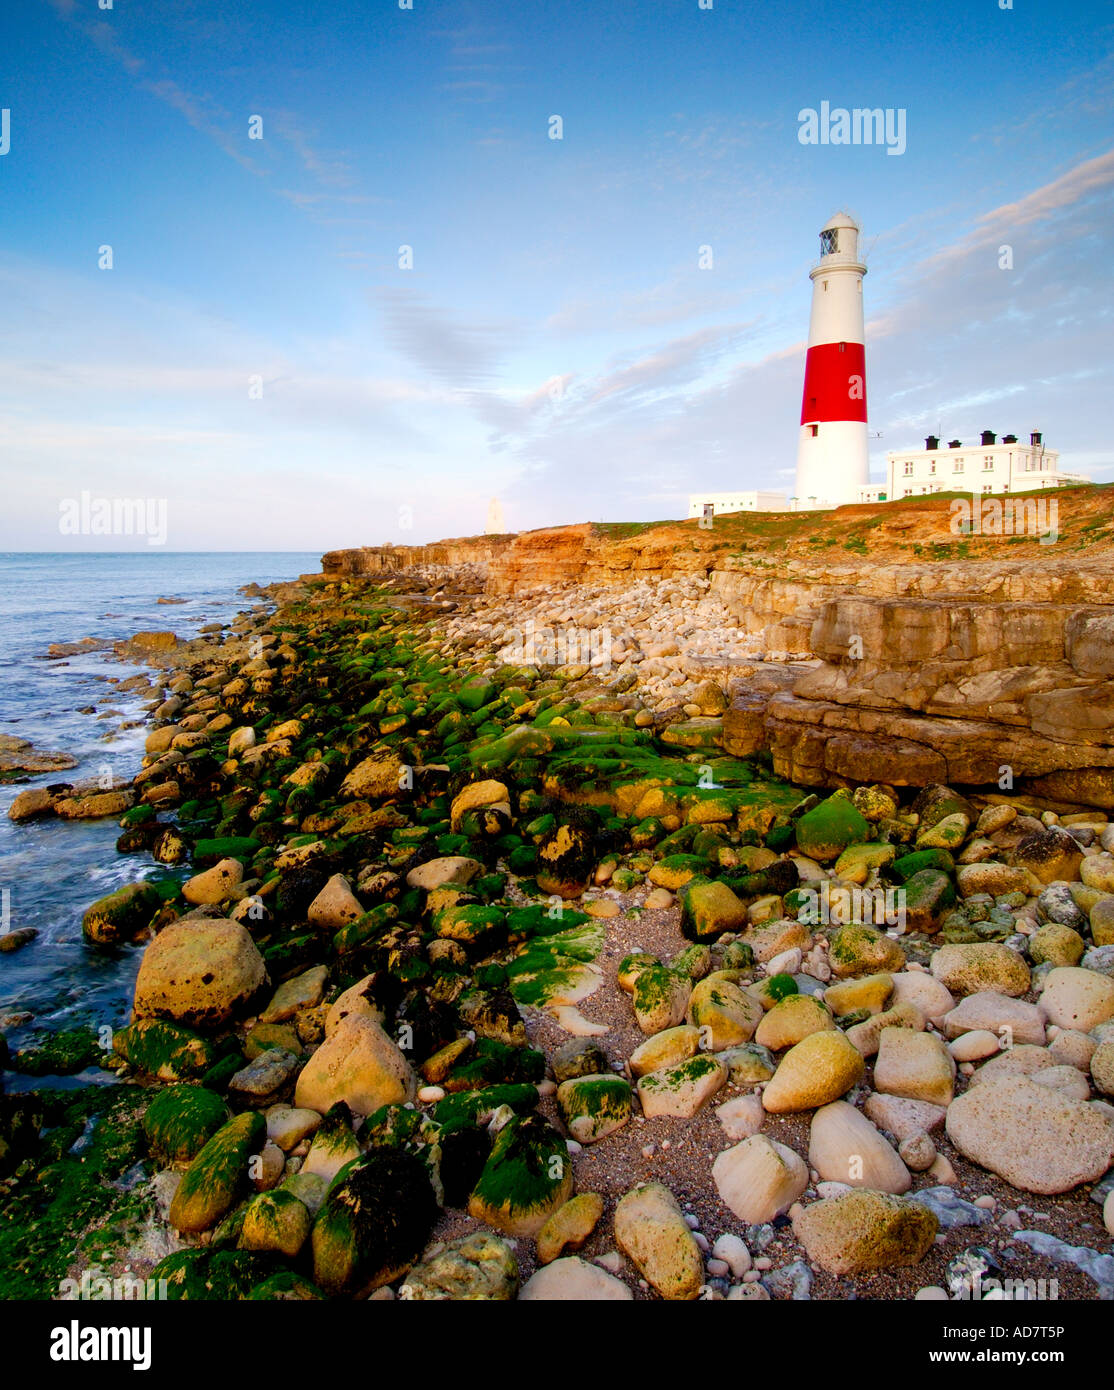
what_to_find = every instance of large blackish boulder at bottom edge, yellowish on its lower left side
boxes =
[312,1150,438,1298]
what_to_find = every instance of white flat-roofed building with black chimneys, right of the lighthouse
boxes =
[859,430,1090,502]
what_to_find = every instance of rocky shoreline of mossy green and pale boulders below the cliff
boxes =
[0,563,1114,1301]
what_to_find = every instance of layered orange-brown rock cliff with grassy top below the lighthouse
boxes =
[323,487,1114,809]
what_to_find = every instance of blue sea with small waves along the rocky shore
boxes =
[0,552,320,1090]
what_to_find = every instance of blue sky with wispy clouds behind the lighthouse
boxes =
[0,0,1114,550]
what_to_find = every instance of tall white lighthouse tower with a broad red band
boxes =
[797,213,869,509]
